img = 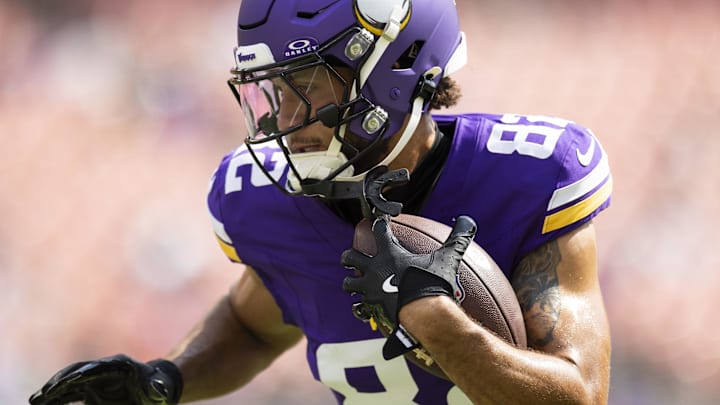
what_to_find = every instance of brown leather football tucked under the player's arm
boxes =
[353,214,527,379]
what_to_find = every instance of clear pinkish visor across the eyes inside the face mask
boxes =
[234,65,349,142]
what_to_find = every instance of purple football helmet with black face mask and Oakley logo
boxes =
[228,0,466,198]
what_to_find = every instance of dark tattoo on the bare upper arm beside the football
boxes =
[511,241,561,348]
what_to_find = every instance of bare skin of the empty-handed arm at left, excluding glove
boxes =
[168,267,302,402]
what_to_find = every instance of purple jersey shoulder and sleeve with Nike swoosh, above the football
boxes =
[422,114,612,276]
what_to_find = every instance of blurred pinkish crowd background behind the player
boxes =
[0,0,720,405]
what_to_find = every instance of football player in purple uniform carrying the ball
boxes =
[30,0,612,405]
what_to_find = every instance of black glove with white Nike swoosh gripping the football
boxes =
[342,216,477,358]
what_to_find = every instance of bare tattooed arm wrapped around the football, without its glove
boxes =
[399,223,610,404]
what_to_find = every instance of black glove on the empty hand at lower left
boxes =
[30,354,183,405]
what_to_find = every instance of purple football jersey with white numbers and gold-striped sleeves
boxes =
[208,114,612,404]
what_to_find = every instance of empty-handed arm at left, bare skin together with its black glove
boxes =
[29,270,301,405]
